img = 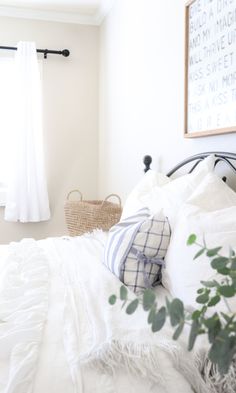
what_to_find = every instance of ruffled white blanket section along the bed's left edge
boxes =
[0,240,49,393]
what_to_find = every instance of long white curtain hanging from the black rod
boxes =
[5,42,50,222]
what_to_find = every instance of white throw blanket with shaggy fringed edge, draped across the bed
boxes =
[61,233,218,393]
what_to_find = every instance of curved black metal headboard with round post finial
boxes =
[143,151,236,176]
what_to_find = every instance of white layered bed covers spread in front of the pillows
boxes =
[0,232,208,393]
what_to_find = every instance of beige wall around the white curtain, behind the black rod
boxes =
[0,17,98,243]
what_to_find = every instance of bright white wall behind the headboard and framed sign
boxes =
[99,0,236,199]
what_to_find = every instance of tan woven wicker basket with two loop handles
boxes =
[64,190,122,236]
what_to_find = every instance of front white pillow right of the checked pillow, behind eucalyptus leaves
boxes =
[162,203,236,311]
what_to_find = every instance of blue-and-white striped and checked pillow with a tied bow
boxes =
[105,208,170,293]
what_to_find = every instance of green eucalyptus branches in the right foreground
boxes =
[109,234,236,375]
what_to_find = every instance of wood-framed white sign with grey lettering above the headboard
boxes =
[185,0,236,138]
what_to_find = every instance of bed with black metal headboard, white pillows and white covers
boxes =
[0,152,236,393]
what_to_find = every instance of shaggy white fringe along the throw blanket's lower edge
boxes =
[80,340,211,393]
